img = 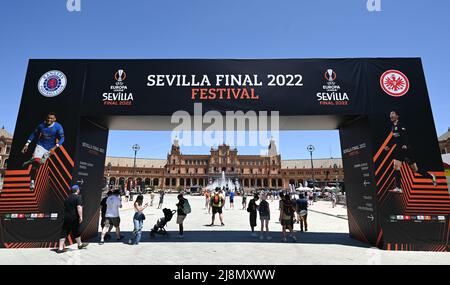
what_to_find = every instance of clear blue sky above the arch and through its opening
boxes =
[0,0,450,158]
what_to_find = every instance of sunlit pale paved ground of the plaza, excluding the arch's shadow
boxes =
[0,194,450,265]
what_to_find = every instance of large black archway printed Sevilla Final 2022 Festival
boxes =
[0,58,450,251]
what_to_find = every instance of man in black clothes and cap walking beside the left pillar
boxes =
[56,185,88,253]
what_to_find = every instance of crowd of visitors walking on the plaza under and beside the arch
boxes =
[57,185,342,253]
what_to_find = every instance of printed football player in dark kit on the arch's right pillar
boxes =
[385,111,437,193]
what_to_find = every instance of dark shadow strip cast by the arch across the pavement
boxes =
[90,230,371,248]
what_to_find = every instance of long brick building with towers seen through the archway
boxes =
[104,136,344,190]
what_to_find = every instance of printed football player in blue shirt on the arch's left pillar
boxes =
[22,112,64,190]
